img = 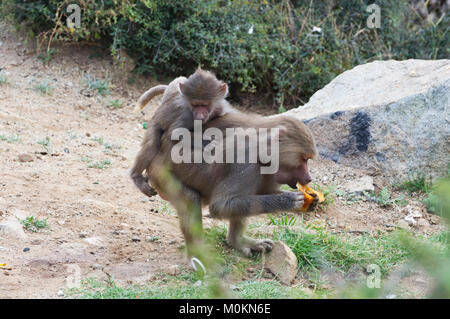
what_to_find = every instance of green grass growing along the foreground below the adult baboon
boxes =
[66,210,450,299]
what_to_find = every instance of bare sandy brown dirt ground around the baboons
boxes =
[0,25,439,298]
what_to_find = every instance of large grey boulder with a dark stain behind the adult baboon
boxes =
[285,60,450,181]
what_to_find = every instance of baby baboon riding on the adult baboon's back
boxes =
[131,68,233,197]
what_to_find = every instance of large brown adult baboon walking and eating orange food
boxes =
[148,113,317,256]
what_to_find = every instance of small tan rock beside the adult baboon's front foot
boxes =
[265,241,297,285]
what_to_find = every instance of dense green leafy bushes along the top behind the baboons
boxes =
[1,0,450,109]
